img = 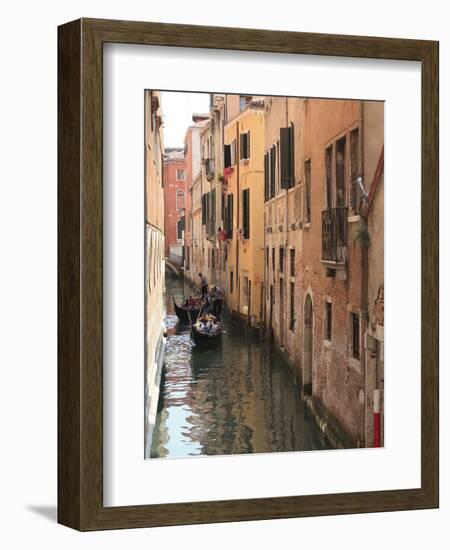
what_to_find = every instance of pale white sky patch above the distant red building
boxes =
[161,92,209,147]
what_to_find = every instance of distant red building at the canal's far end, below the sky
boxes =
[163,149,186,267]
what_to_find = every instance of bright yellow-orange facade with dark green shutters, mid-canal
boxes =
[223,96,264,329]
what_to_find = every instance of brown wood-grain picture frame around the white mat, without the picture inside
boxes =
[58,19,439,531]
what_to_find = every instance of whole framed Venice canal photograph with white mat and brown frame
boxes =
[58,19,439,531]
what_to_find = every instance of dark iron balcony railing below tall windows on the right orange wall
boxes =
[322,206,348,263]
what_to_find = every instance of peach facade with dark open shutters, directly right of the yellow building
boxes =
[264,97,305,365]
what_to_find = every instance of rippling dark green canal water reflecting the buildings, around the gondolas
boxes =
[151,278,326,458]
